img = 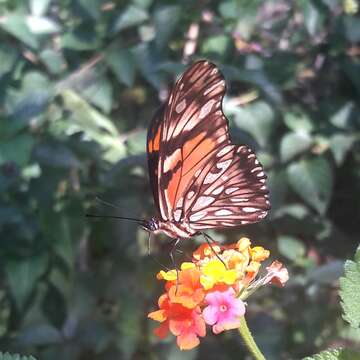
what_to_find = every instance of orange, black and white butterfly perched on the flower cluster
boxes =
[143,61,270,239]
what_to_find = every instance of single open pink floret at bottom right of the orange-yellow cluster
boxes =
[203,288,245,334]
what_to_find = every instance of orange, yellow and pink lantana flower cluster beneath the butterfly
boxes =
[148,238,288,350]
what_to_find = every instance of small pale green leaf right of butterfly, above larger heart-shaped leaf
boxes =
[280,132,312,162]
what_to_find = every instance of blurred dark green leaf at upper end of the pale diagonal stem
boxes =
[105,47,135,87]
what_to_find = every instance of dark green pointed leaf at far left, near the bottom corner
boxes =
[5,255,48,310]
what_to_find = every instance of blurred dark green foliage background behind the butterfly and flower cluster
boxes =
[0,0,360,360]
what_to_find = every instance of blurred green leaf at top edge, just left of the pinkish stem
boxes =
[153,5,181,50]
